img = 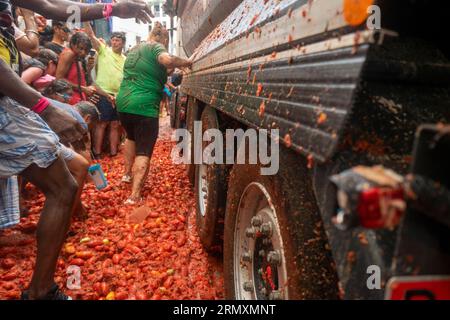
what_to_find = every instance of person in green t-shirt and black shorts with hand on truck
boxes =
[116,23,192,204]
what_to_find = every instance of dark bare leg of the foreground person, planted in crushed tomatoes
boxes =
[22,159,78,299]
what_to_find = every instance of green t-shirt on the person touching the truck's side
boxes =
[116,43,167,118]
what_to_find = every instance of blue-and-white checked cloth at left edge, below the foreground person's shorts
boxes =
[0,176,20,230]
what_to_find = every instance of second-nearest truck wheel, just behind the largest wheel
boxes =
[195,107,226,251]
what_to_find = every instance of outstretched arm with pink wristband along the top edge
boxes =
[11,0,153,23]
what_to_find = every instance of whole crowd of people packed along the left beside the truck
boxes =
[0,0,192,300]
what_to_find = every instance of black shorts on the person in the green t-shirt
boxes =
[119,113,159,158]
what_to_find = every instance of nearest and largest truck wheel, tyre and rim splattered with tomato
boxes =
[224,150,338,300]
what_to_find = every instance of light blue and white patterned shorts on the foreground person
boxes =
[0,97,62,179]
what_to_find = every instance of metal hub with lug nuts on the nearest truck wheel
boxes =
[233,183,289,300]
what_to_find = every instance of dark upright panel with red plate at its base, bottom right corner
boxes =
[387,125,450,300]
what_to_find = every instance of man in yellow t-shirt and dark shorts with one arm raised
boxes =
[85,23,126,156]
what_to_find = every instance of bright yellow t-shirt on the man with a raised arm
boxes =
[95,43,126,95]
